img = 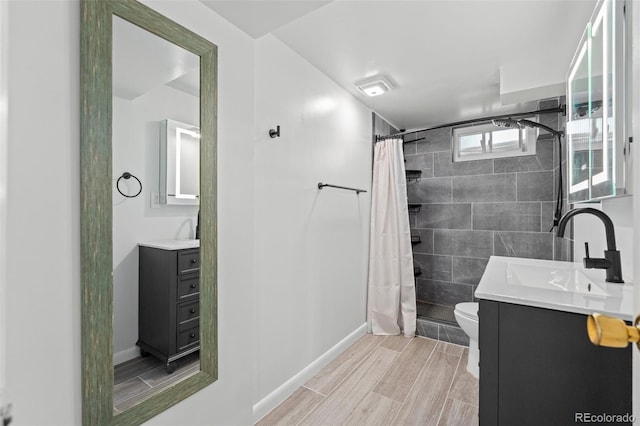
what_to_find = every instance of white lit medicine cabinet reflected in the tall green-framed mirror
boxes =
[160,119,200,205]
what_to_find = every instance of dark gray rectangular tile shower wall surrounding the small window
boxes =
[404,99,573,306]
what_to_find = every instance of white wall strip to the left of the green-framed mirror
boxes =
[6,1,80,425]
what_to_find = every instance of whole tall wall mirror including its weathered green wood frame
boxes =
[81,0,217,424]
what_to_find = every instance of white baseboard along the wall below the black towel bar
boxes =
[253,323,367,424]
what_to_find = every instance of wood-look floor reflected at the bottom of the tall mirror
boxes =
[113,352,200,414]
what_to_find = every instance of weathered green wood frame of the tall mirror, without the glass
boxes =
[80,0,218,425]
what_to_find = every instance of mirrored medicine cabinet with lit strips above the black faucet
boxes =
[566,0,629,203]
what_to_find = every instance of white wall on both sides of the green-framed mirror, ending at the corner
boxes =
[6,1,254,425]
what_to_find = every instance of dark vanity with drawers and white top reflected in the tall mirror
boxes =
[137,242,200,373]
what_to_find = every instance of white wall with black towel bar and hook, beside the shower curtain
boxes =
[247,35,372,419]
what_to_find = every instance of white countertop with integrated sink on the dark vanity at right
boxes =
[475,256,635,321]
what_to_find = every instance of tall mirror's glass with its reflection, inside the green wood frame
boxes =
[112,16,200,414]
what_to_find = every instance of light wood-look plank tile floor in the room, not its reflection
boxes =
[257,334,478,426]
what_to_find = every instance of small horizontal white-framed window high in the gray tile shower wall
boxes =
[451,117,538,162]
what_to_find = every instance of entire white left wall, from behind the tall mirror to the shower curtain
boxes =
[3,0,371,425]
